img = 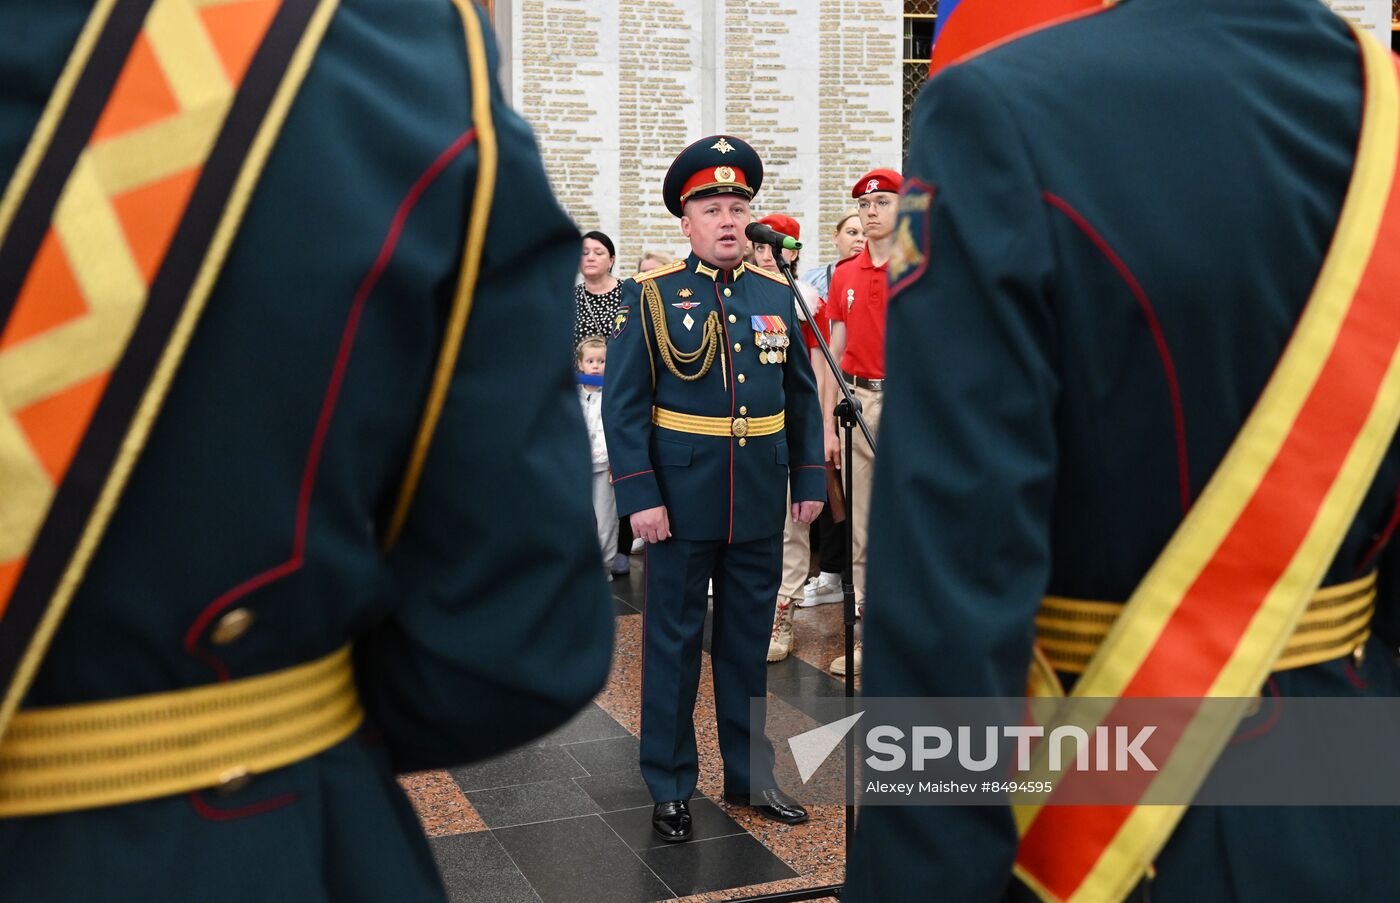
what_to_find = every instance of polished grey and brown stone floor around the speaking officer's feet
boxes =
[400,556,846,903]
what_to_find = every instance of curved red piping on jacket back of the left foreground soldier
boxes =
[185,129,476,682]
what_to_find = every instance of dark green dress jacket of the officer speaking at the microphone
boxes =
[603,253,826,542]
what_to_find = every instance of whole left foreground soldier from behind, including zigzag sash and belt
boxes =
[0,0,613,903]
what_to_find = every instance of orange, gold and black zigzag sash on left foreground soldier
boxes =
[0,0,336,735]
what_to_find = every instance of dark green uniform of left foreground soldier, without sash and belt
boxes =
[0,0,613,902]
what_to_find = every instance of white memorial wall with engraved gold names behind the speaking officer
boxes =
[509,0,903,266]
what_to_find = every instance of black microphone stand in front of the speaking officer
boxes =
[748,242,875,902]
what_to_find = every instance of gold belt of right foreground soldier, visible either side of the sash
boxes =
[1036,573,1376,673]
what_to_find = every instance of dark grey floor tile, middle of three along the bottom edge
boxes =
[491,815,675,903]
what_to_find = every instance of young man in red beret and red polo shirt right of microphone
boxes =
[826,169,900,675]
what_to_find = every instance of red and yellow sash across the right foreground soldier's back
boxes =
[1014,24,1400,902]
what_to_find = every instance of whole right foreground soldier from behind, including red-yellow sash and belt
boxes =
[843,0,1400,903]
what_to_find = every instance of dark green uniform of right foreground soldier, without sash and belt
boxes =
[843,0,1400,903]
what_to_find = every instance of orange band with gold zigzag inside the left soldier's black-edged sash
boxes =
[0,0,280,604]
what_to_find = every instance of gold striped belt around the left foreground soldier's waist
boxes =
[0,645,363,818]
